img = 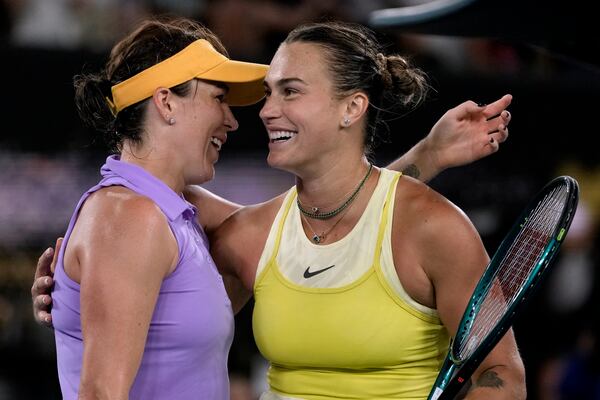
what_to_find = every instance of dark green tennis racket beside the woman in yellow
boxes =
[428,176,579,400]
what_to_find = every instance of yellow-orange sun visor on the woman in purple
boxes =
[109,39,269,115]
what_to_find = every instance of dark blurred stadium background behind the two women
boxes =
[0,0,600,400]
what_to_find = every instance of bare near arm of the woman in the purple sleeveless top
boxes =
[73,196,178,398]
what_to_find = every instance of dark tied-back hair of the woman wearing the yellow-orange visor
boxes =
[74,18,227,151]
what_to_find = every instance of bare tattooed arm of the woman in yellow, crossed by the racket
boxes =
[422,192,524,399]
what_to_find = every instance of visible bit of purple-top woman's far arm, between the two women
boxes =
[184,186,242,236]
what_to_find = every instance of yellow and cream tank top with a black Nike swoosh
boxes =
[253,169,449,400]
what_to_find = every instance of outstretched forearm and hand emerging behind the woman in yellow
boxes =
[387,94,512,182]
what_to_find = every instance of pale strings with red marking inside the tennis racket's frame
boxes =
[455,185,568,360]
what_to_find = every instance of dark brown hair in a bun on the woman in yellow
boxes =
[284,22,429,152]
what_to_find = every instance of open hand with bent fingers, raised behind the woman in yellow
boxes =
[423,94,512,171]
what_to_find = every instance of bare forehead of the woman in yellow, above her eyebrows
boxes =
[265,42,329,84]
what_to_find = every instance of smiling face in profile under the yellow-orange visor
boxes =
[170,80,238,184]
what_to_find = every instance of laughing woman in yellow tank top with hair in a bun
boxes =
[207,23,525,399]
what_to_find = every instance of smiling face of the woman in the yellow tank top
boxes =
[260,42,346,175]
